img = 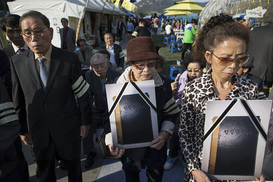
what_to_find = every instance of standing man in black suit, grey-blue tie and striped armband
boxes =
[11,11,92,182]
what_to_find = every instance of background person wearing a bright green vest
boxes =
[181,19,197,60]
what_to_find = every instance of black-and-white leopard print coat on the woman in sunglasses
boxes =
[178,69,258,182]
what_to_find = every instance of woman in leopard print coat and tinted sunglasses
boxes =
[178,14,258,182]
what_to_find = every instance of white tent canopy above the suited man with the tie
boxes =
[7,0,124,47]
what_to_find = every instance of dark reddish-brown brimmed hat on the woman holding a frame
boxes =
[126,36,160,64]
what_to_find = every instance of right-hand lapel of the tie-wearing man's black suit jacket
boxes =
[45,46,61,97]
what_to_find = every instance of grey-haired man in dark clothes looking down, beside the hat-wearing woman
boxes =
[83,53,121,169]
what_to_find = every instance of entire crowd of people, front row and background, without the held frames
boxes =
[0,11,273,182]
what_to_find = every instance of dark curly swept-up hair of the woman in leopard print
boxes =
[192,14,250,60]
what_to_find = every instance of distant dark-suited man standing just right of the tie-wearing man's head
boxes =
[60,18,76,52]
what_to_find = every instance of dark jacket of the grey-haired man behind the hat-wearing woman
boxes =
[85,69,121,129]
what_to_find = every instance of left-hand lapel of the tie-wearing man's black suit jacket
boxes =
[26,51,42,90]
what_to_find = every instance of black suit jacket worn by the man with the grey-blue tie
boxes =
[11,46,92,150]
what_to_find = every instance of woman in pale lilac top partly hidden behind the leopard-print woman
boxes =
[164,54,203,170]
